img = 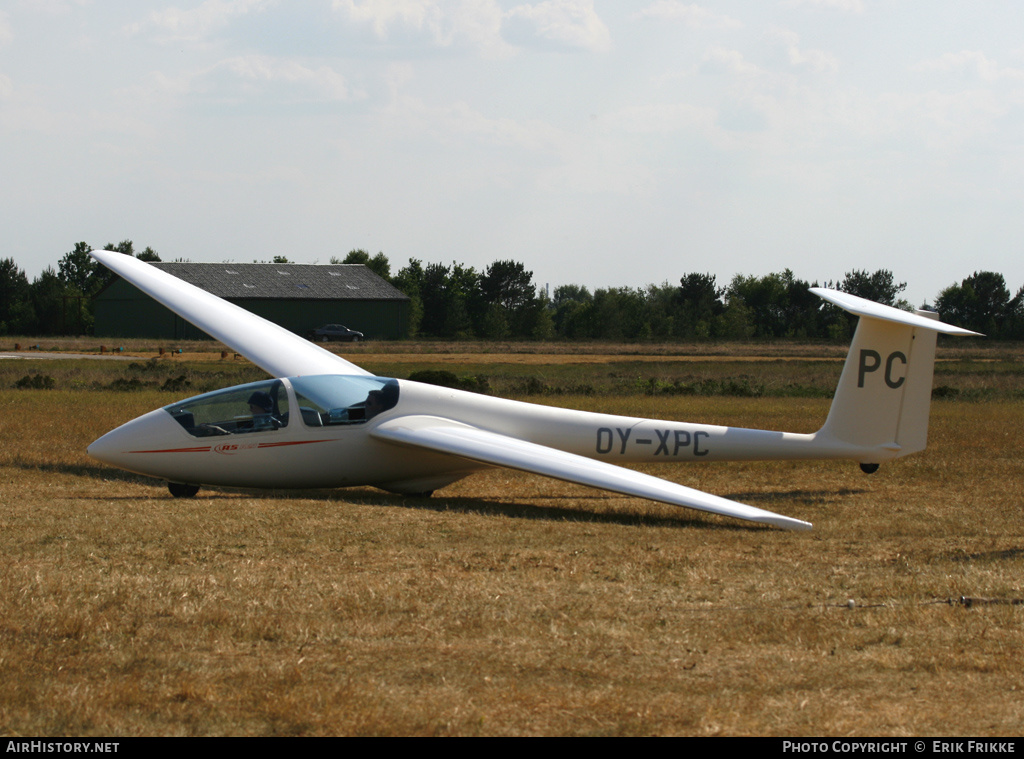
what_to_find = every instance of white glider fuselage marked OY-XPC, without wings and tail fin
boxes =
[89,370,868,493]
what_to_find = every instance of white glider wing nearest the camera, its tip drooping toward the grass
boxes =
[370,416,811,530]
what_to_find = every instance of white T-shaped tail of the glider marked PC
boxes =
[811,288,978,464]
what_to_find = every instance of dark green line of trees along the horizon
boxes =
[0,240,1024,342]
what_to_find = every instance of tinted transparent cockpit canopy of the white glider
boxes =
[164,374,398,437]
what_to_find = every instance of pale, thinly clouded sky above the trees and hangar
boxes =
[0,0,1024,304]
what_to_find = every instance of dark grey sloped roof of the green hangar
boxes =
[153,262,409,300]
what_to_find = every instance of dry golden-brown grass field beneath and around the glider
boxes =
[0,344,1024,735]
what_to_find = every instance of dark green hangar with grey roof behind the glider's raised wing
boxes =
[94,262,409,340]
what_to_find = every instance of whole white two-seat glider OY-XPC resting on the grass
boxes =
[89,251,977,530]
